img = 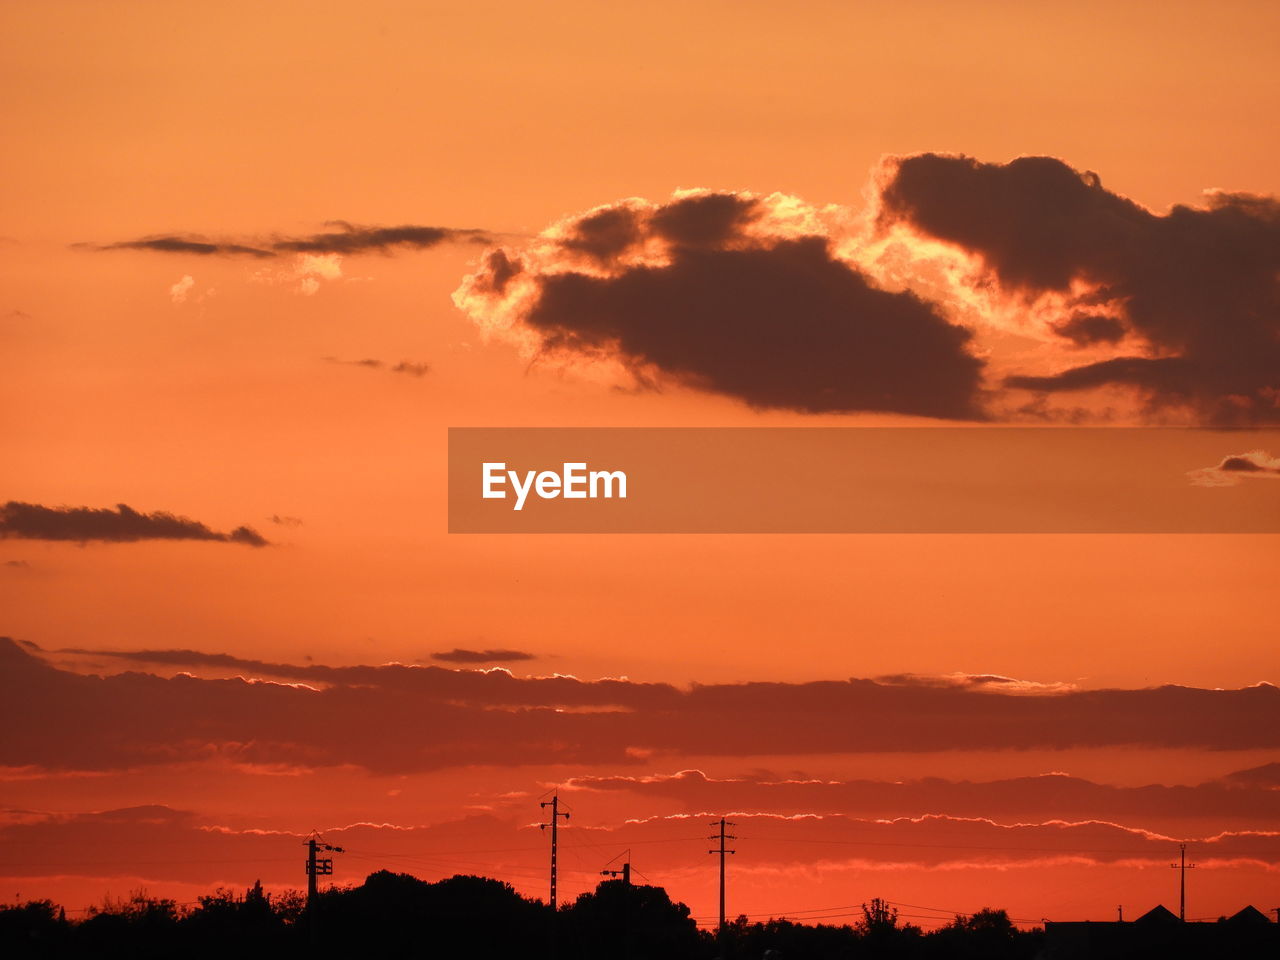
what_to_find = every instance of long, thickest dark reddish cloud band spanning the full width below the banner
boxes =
[10,643,1280,772]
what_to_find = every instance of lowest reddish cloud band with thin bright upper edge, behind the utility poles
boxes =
[0,804,1280,896]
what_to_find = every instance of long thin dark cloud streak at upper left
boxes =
[73,220,493,259]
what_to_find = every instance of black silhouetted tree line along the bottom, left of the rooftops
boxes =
[0,870,1042,960]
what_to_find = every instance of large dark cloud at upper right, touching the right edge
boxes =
[881,154,1280,424]
